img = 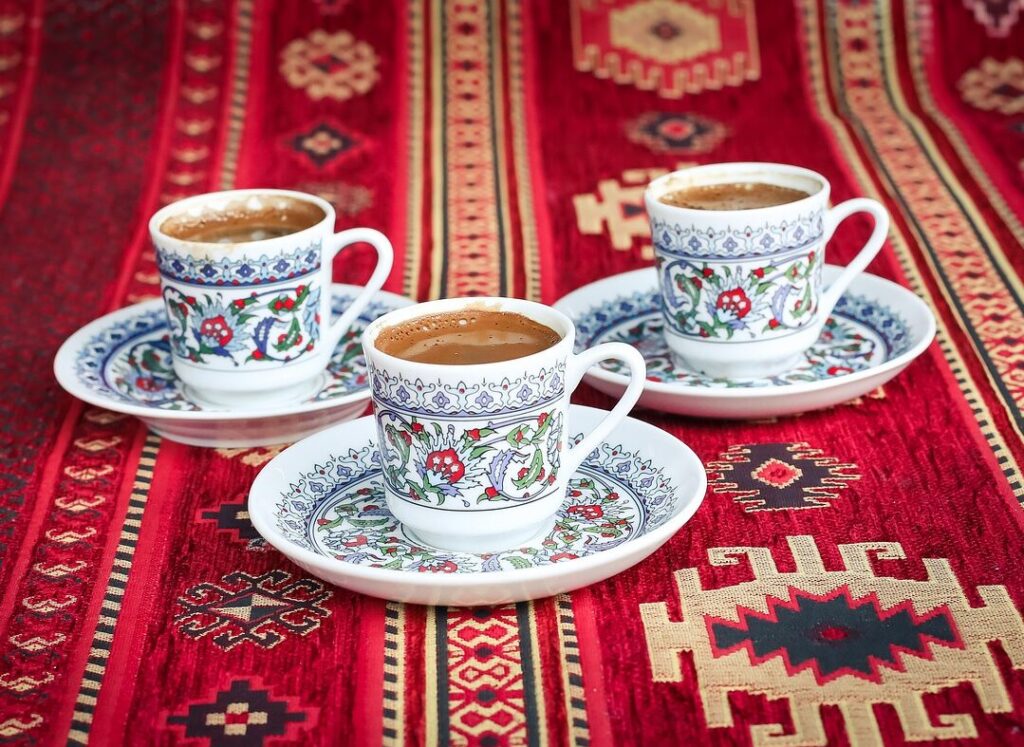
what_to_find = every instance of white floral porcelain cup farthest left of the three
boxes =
[150,190,394,409]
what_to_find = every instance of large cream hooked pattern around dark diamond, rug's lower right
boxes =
[640,536,1024,747]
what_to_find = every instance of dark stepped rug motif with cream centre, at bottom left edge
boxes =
[167,679,318,747]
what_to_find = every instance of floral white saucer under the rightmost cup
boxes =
[554,264,935,419]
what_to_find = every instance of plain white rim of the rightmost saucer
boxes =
[552,263,936,400]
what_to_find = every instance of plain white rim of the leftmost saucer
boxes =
[53,283,416,422]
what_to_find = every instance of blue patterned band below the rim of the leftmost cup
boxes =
[157,241,322,287]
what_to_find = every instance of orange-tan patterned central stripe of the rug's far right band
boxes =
[826,2,1024,461]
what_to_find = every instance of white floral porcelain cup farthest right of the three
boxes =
[644,163,889,379]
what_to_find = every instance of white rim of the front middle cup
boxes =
[362,296,575,377]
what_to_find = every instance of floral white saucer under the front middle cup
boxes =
[249,405,708,605]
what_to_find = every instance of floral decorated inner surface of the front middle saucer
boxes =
[274,434,677,573]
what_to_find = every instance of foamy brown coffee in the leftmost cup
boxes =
[160,196,325,244]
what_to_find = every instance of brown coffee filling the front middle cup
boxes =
[375,308,561,366]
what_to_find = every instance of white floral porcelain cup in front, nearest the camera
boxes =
[362,298,646,552]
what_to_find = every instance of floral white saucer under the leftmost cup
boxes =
[53,283,413,448]
